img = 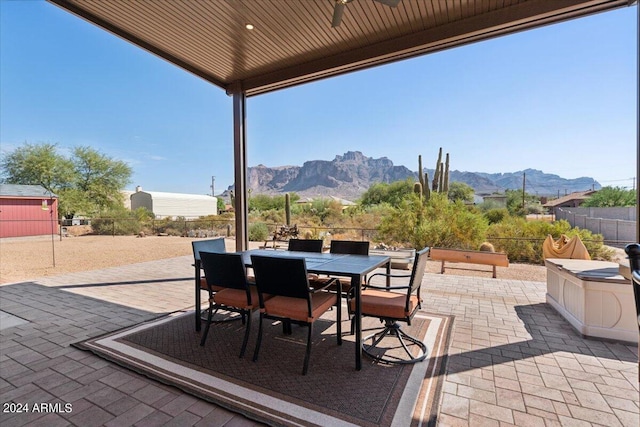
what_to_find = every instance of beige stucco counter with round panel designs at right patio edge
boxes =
[545,258,638,343]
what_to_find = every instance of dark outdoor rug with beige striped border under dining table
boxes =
[78,310,453,426]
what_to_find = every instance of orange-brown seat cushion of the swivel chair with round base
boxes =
[350,289,419,319]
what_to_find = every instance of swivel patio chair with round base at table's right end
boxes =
[347,248,429,364]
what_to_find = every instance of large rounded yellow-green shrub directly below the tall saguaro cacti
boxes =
[378,194,488,249]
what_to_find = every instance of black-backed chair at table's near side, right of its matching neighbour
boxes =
[251,255,342,375]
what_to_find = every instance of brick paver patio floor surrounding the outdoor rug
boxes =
[0,257,640,427]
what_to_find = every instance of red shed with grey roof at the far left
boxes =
[0,184,58,238]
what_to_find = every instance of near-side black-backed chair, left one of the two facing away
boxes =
[200,252,268,357]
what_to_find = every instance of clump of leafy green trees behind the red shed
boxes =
[1,144,132,218]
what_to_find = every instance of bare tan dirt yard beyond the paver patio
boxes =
[0,235,546,284]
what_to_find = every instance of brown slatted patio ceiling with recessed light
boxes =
[49,0,635,96]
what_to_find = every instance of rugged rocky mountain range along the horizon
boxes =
[223,151,601,200]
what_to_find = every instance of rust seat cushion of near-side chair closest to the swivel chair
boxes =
[264,292,338,323]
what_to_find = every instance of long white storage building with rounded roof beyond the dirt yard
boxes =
[131,187,218,218]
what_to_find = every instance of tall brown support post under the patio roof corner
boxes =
[233,90,249,251]
